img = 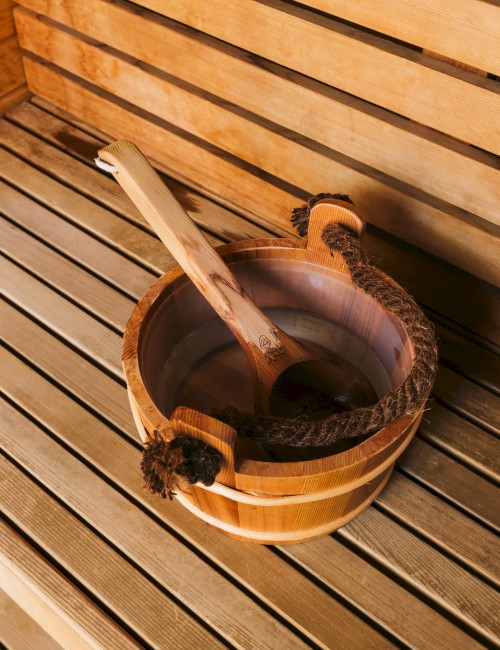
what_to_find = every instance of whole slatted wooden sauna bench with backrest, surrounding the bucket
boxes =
[0,0,500,650]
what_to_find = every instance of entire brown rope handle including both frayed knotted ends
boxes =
[142,194,438,497]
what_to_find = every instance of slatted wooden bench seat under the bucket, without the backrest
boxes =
[0,88,499,650]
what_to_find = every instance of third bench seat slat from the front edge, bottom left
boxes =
[0,394,380,648]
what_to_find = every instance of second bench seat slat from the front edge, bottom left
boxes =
[0,459,224,650]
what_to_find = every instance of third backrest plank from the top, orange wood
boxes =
[11,0,498,221]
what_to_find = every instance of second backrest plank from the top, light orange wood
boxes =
[16,0,499,153]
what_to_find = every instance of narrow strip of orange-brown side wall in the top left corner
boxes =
[0,0,28,115]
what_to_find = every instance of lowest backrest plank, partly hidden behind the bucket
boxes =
[16,71,500,341]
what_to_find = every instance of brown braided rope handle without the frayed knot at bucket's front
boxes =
[213,194,438,447]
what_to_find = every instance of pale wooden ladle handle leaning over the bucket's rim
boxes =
[97,140,280,362]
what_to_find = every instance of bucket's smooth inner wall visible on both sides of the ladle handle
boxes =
[139,251,412,460]
